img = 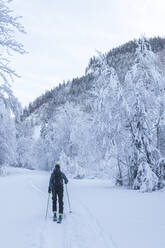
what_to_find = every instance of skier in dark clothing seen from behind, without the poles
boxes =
[48,164,68,223]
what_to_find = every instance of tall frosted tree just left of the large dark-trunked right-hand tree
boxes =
[85,53,121,176]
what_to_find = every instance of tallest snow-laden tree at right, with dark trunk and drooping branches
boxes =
[124,39,165,190]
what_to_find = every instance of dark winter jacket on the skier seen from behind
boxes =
[49,168,68,192]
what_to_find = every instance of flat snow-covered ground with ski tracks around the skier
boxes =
[0,169,165,248]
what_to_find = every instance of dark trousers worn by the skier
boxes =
[52,188,64,214]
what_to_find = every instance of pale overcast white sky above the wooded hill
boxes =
[10,0,165,105]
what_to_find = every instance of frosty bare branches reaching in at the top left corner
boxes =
[0,0,25,86]
